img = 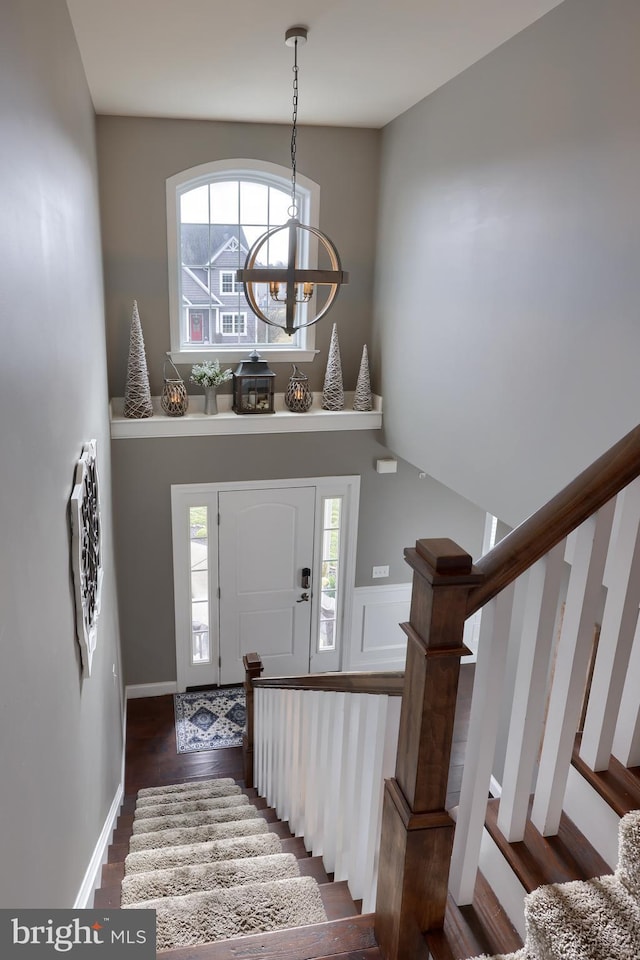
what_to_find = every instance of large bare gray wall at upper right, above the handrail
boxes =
[372,0,640,525]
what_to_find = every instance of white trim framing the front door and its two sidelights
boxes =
[171,475,360,691]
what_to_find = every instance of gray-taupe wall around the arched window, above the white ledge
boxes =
[97,117,380,396]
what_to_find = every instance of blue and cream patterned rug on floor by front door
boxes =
[174,687,246,753]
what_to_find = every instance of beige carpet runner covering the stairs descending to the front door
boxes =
[122,778,327,950]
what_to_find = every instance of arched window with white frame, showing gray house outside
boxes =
[167,160,320,363]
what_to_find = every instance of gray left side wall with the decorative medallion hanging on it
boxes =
[0,0,123,907]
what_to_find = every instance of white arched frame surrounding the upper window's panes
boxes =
[166,158,320,363]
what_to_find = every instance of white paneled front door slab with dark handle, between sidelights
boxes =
[218,487,315,684]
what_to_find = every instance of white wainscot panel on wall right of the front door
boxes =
[344,583,411,670]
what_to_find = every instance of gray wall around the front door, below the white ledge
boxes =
[112,431,484,684]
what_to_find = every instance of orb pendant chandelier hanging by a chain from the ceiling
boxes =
[236,27,349,336]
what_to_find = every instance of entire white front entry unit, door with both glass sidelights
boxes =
[171,476,360,690]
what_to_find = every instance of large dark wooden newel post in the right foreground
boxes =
[375,539,482,960]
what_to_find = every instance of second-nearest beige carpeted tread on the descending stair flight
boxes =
[122,853,300,905]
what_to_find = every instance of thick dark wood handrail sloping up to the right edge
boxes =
[467,425,640,617]
